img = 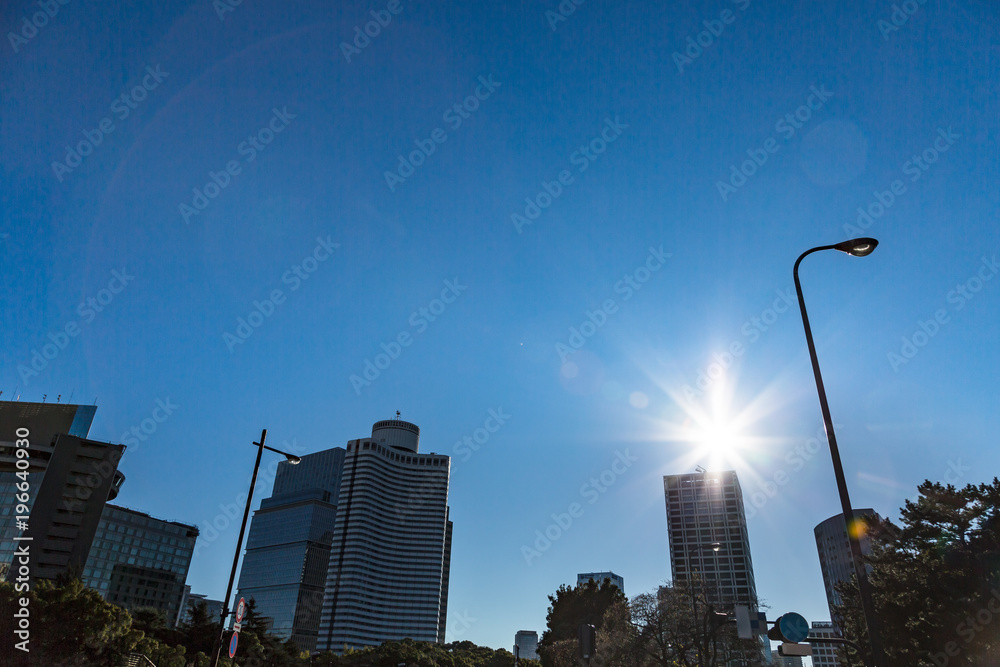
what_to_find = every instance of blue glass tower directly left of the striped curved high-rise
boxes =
[237,447,346,652]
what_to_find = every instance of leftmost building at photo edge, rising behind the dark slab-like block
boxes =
[0,401,102,580]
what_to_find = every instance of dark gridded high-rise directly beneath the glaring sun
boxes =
[663,470,757,610]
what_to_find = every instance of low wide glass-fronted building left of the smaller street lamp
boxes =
[83,505,198,627]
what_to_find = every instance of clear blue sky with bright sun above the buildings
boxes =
[0,0,1000,646]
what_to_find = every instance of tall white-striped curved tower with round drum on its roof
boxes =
[317,419,452,653]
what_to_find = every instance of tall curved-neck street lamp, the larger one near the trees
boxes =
[792,238,885,667]
